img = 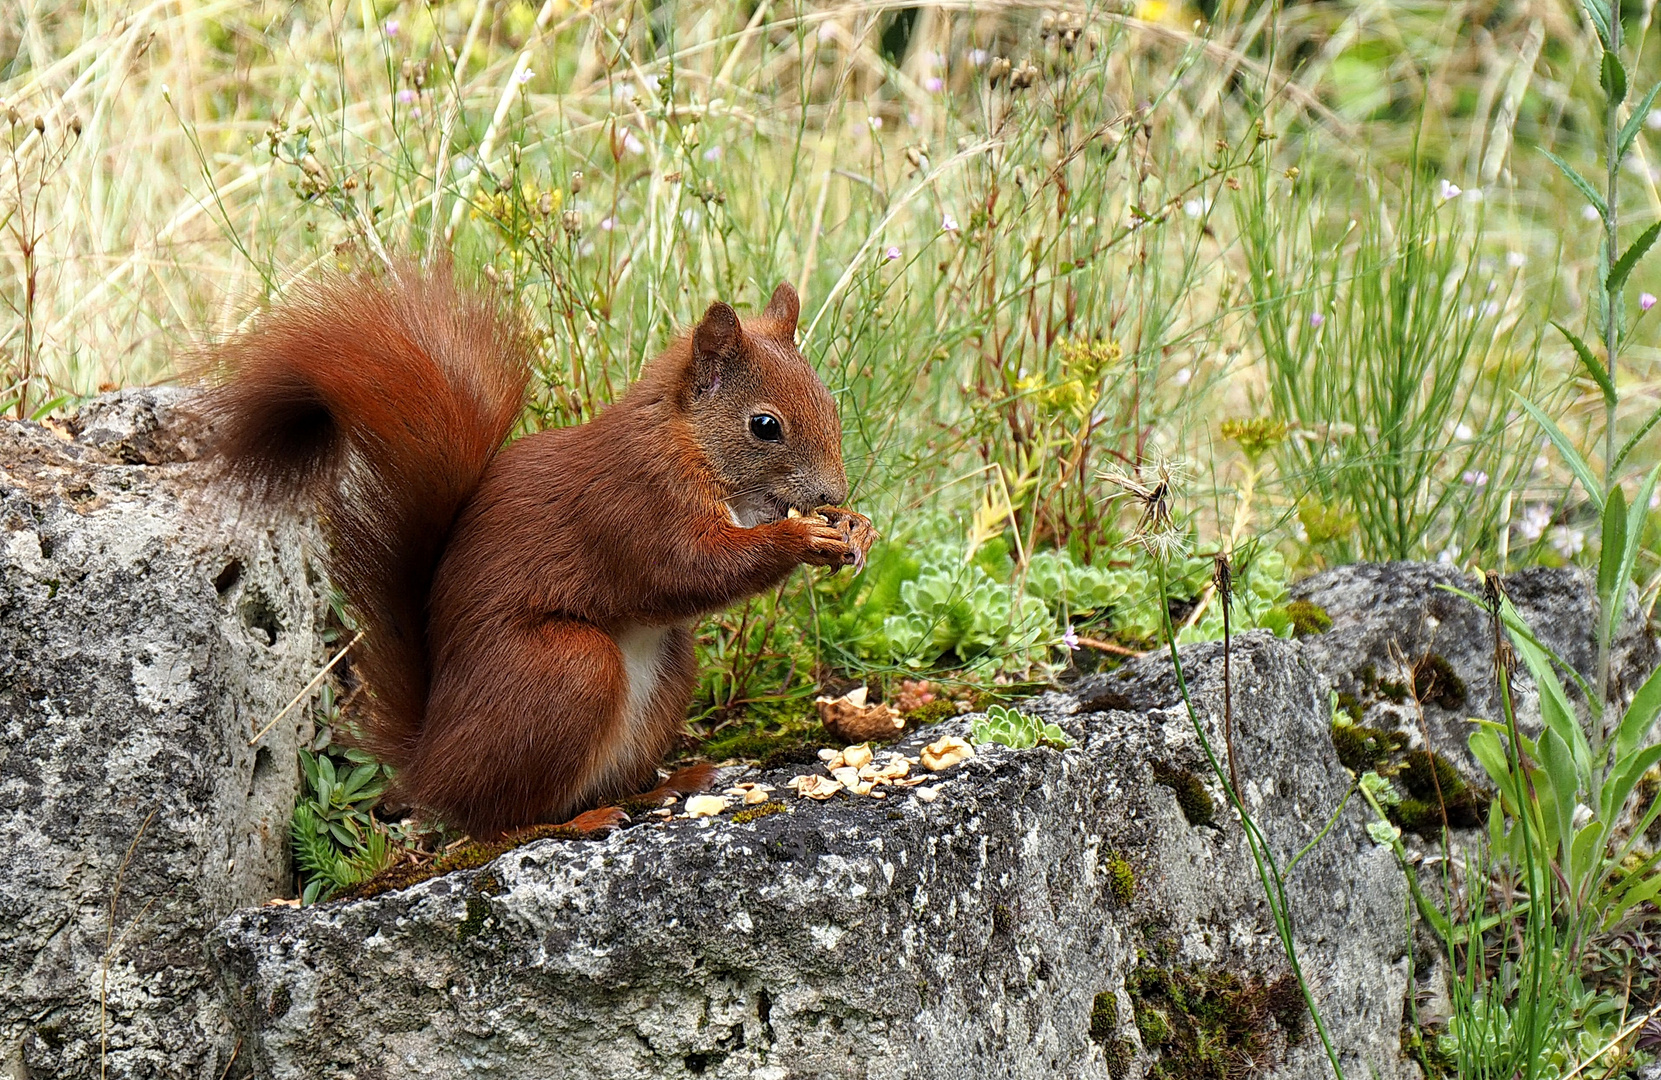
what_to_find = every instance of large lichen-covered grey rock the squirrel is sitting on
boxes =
[211,633,1417,1080]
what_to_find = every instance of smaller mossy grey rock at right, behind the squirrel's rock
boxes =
[1292,563,1661,779]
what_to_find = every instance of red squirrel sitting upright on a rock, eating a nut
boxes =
[204,266,875,836]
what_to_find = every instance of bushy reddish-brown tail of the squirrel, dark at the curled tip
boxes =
[204,266,533,764]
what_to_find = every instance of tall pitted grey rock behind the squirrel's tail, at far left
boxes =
[0,390,322,1080]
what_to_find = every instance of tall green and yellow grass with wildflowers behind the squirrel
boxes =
[0,0,1661,1075]
